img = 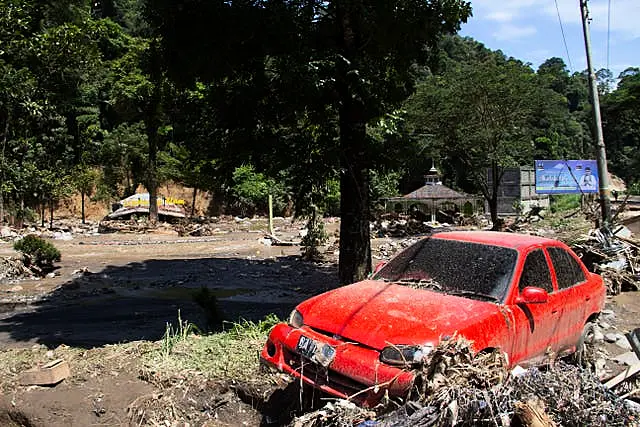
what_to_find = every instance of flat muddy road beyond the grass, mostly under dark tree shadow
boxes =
[0,229,337,348]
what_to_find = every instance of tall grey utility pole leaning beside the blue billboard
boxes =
[580,0,611,225]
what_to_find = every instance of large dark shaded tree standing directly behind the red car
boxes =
[146,0,471,283]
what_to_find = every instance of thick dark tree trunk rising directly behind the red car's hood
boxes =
[336,2,371,284]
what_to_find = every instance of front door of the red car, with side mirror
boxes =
[510,248,560,363]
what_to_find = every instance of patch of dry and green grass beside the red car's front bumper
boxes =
[144,315,280,382]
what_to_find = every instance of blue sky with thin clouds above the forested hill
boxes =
[460,0,640,77]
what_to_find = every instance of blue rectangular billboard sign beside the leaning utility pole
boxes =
[535,160,599,194]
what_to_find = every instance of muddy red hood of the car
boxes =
[298,281,499,350]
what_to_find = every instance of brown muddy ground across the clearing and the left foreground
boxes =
[0,219,640,426]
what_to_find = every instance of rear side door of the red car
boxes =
[547,247,591,352]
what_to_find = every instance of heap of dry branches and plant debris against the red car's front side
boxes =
[291,337,640,427]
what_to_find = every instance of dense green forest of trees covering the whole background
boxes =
[0,0,640,282]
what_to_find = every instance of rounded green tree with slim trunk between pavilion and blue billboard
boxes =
[407,54,548,228]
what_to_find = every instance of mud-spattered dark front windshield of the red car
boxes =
[373,238,518,302]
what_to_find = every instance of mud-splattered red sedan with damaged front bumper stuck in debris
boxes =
[261,231,606,405]
